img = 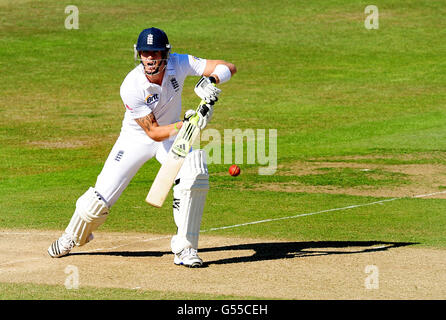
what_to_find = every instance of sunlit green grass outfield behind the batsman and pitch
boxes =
[0,0,446,299]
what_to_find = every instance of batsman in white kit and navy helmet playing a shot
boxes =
[48,27,236,267]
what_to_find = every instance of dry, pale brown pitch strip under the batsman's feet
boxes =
[0,230,446,299]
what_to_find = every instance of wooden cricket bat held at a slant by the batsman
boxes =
[146,100,206,208]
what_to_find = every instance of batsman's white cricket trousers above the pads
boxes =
[95,133,173,208]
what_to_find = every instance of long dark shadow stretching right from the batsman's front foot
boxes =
[199,241,417,265]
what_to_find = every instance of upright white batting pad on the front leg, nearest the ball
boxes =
[171,150,209,253]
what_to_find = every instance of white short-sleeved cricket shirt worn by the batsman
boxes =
[120,53,206,142]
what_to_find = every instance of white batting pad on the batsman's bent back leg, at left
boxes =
[65,187,109,246]
